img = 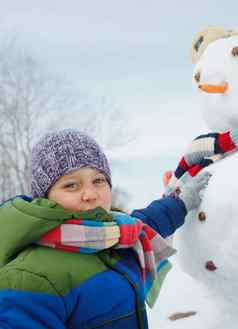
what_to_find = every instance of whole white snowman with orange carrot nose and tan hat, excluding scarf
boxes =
[165,28,238,306]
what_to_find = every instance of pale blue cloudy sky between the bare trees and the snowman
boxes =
[0,0,238,205]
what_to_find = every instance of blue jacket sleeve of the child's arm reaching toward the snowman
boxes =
[131,196,187,238]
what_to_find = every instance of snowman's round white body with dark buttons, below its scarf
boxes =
[176,153,238,304]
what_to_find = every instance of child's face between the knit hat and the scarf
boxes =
[48,167,112,211]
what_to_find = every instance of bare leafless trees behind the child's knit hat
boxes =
[0,40,136,201]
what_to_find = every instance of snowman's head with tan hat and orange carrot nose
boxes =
[192,28,238,131]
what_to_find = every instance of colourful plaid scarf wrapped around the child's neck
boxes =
[37,212,175,307]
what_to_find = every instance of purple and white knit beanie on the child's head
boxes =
[31,129,112,198]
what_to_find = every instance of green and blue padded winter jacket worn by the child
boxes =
[0,197,186,329]
